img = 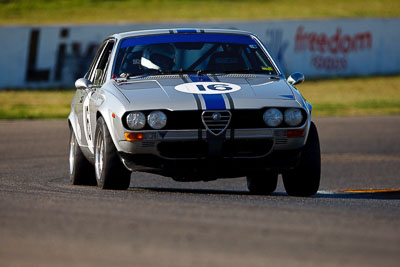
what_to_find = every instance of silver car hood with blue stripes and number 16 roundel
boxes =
[115,76,298,110]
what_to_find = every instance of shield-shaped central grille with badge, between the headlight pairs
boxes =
[201,110,231,135]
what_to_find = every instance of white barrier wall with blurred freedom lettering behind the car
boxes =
[0,18,400,88]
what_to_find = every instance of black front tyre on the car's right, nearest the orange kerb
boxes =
[282,122,321,197]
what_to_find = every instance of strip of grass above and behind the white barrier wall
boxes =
[0,0,400,25]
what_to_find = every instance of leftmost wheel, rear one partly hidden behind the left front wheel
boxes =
[69,127,96,185]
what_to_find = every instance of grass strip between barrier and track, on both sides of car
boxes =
[0,76,400,119]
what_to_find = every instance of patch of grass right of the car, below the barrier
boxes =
[298,76,400,116]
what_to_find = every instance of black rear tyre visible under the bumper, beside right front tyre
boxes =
[246,171,278,195]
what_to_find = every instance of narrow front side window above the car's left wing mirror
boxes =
[89,40,114,85]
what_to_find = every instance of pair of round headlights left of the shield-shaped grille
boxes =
[126,111,167,130]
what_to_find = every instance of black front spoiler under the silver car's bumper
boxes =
[119,149,301,181]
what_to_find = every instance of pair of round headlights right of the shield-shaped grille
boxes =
[263,108,303,127]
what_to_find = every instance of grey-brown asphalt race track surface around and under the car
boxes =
[0,116,400,267]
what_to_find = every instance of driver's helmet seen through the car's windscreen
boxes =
[141,44,176,71]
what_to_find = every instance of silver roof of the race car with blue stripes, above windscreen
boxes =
[110,28,254,39]
